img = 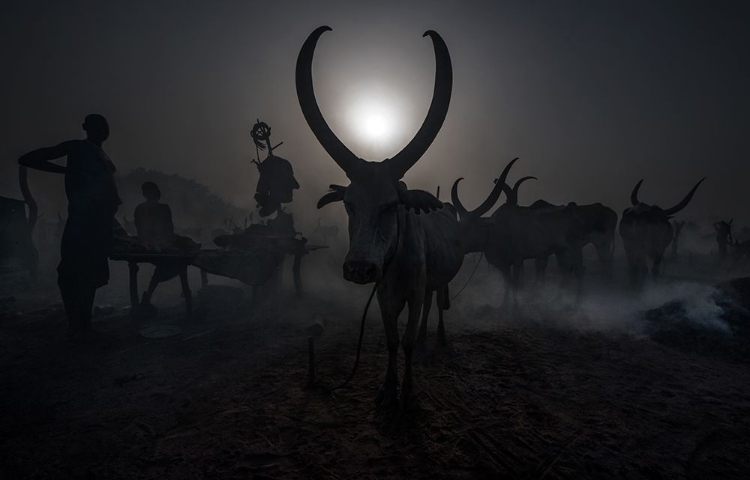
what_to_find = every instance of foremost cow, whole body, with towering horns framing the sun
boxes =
[296,26,464,408]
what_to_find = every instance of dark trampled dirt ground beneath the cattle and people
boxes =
[0,253,750,480]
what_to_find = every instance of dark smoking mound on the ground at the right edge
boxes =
[645,278,750,362]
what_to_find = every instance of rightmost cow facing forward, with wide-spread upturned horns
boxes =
[620,178,705,289]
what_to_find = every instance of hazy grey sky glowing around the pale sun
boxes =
[0,0,750,227]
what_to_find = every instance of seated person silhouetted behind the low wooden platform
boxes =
[134,182,197,315]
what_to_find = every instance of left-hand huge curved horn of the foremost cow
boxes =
[295,26,360,178]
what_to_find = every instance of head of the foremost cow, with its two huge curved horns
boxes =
[296,26,453,284]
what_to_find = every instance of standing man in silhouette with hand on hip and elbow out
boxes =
[18,114,122,336]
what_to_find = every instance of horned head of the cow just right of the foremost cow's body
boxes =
[451,158,520,253]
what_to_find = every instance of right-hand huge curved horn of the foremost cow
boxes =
[387,30,453,179]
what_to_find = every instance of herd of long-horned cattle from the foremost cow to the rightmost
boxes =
[296,26,724,406]
